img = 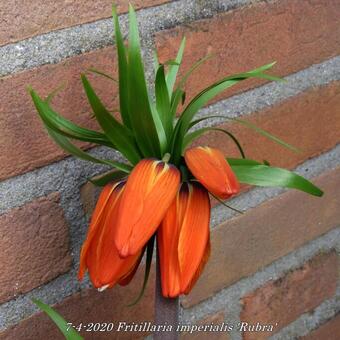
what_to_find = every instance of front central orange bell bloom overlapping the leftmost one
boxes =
[115,159,180,258]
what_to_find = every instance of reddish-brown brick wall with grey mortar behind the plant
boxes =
[0,0,340,340]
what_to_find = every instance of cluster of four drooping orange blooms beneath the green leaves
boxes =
[79,147,239,297]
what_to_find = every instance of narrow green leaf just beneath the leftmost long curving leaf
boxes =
[47,127,132,173]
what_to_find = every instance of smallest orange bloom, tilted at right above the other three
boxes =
[184,146,240,199]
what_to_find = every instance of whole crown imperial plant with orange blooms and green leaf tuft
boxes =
[30,6,322,297]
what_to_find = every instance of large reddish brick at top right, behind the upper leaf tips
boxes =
[156,0,340,105]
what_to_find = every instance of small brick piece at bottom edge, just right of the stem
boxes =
[180,311,230,340]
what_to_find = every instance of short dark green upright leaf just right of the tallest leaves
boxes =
[155,65,173,140]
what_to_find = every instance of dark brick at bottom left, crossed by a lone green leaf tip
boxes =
[0,268,154,340]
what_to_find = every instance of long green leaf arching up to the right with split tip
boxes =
[171,64,280,164]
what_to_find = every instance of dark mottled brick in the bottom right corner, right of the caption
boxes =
[241,252,337,340]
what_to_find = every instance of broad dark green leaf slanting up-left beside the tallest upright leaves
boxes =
[81,74,141,164]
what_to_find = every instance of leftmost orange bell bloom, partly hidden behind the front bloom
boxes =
[78,182,141,289]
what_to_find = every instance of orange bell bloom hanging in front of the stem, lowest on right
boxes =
[157,182,210,298]
